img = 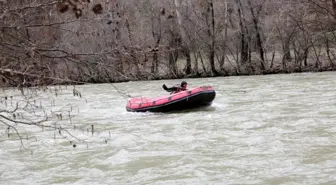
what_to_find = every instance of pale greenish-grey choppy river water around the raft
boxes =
[0,72,336,185]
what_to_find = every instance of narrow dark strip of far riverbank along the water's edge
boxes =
[0,62,336,88]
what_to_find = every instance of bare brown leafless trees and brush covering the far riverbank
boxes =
[0,0,336,86]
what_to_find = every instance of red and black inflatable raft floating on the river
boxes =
[126,86,216,112]
